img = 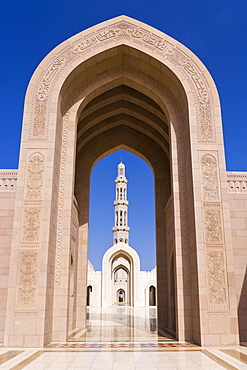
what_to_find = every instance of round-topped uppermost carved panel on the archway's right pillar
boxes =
[201,154,219,202]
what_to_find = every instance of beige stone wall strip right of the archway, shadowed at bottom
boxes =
[227,172,247,342]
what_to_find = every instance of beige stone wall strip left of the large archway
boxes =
[0,170,17,342]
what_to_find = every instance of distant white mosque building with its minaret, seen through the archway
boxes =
[87,162,156,307]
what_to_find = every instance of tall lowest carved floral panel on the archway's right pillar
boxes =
[206,250,227,309]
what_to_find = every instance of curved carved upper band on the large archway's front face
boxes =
[24,16,222,143]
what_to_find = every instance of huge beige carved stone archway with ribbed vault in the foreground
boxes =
[5,16,238,347]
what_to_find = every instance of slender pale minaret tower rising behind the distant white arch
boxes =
[112,160,130,244]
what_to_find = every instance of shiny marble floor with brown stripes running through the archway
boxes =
[0,307,247,370]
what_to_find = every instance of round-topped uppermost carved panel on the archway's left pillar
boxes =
[26,153,44,201]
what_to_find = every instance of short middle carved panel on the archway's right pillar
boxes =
[205,208,222,243]
